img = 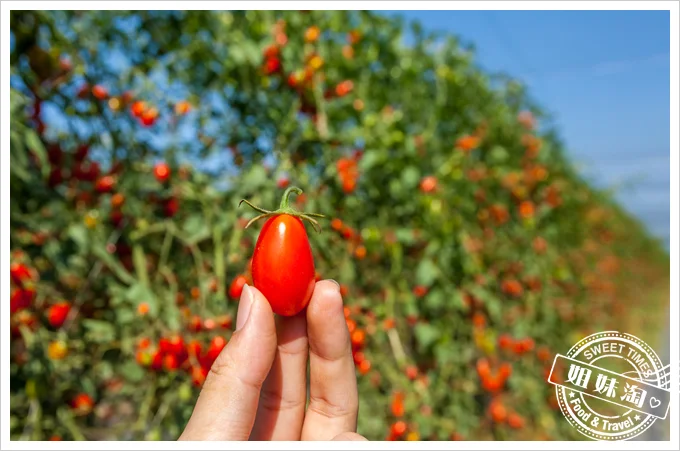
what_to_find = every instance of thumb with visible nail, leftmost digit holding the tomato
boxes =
[180,285,276,440]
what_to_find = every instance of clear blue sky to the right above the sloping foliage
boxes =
[383,11,670,247]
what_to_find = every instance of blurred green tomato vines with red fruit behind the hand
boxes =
[10,11,669,440]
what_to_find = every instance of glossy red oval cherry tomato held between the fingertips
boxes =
[252,214,316,316]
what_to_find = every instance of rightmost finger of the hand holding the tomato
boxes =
[302,280,359,440]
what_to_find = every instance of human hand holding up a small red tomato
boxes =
[179,280,366,440]
